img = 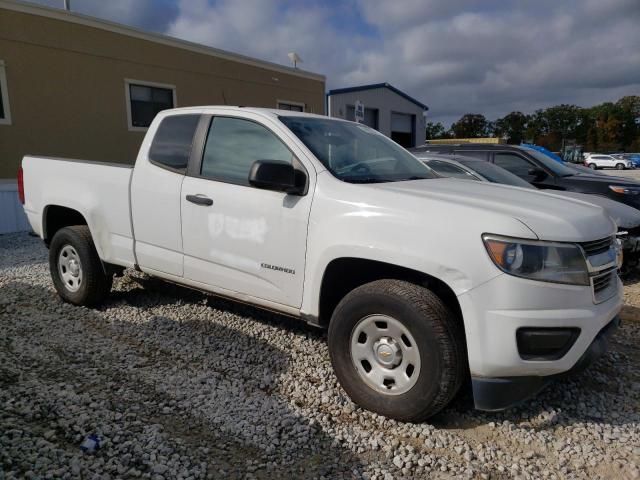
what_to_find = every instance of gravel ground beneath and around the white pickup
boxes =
[0,234,640,479]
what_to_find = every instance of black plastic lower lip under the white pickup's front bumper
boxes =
[471,316,620,411]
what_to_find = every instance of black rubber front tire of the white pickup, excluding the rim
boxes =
[328,280,467,422]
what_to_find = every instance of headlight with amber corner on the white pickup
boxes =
[482,234,589,285]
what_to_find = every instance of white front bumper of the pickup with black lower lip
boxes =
[458,274,623,410]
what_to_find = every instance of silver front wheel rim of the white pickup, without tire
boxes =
[351,315,420,395]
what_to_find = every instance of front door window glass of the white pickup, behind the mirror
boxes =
[200,117,293,185]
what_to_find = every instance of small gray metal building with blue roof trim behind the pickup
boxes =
[327,83,429,148]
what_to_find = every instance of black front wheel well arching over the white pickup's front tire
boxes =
[318,258,464,331]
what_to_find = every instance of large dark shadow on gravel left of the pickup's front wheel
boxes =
[0,282,363,478]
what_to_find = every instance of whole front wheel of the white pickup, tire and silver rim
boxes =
[328,280,466,422]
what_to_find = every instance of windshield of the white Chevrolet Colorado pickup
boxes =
[280,117,436,183]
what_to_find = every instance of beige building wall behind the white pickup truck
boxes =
[0,0,325,179]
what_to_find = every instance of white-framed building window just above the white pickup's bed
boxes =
[125,80,176,130]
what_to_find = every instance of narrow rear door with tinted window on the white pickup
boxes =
[131,114,200,277]
